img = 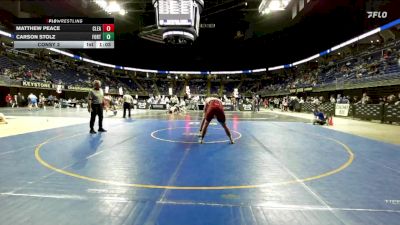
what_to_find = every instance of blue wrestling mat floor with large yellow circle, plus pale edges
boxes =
[0,109,400,225]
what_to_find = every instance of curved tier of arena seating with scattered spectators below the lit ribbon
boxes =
[0,35,400,95]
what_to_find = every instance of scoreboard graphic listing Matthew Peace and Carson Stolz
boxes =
[13,18,115,49]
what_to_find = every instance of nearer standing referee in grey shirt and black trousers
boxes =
[88,80,106,134]
